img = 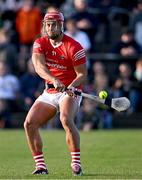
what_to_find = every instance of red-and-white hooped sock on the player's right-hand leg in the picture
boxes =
[71,149,81,167]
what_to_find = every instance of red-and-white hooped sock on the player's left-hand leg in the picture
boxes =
[33,153,47,169]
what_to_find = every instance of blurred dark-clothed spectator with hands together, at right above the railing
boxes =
[111,30,142,57]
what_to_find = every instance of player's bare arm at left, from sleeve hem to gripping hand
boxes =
[32,53,64,91]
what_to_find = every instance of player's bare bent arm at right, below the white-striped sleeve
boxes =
[68,64,87,87]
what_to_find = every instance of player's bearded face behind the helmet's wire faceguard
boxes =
[45,20,61,39]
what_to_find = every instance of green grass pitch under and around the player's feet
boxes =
[0,130,142,179]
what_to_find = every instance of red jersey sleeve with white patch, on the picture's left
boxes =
[33,39,44,54]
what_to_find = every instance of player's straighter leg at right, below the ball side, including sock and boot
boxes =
[60,95,82,175]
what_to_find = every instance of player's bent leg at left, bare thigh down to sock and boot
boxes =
[24,101,56,174]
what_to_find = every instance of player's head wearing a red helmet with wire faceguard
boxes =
[43,11,64,40]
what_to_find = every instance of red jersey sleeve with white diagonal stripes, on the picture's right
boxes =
[72,43,86,66]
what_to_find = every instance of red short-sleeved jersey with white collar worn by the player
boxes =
[33,34,86,92]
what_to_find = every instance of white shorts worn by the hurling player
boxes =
[36,90,82,111]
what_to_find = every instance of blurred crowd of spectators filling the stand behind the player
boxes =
[0,0,142,130]
